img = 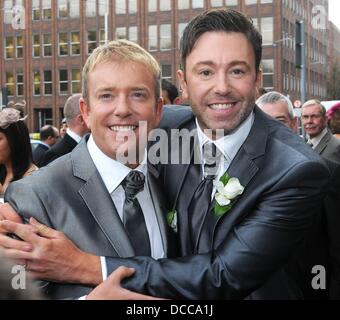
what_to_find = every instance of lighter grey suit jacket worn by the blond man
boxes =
[5,139,174,299]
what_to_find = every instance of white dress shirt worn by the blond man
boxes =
[87,135,164,280]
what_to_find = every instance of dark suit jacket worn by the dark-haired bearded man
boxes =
[107,107,329,299]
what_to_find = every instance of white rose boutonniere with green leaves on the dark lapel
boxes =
[214,172,244,217]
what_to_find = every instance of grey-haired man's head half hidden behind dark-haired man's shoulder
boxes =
[256,91,298,133]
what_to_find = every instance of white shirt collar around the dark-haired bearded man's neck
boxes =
[196,112,255,163]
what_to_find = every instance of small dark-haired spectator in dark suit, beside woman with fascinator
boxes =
[33,125,59,168]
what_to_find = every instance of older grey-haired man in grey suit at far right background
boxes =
[301,100,340,163]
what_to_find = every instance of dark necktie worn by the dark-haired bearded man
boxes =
[188,143,221,250]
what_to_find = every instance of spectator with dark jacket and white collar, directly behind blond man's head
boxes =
[40,94,90,166]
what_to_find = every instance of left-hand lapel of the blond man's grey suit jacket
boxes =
[71,139,134,257]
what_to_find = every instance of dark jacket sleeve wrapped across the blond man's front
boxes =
[107,161,329,299]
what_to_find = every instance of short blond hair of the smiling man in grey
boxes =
[82,40,162,104]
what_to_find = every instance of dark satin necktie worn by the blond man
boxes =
[122,171,151,256]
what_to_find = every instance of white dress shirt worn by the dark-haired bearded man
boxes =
[196,112,254,199]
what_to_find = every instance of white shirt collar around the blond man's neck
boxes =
[87,134,147,193]
